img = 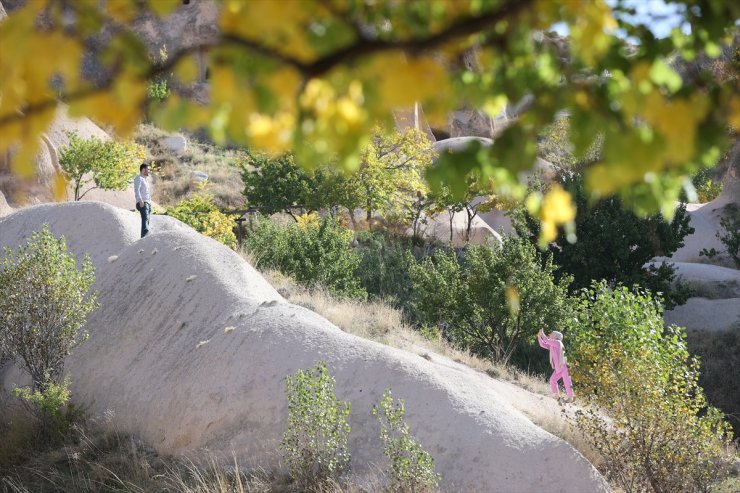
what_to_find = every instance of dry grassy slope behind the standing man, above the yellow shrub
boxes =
[136,124,244,208]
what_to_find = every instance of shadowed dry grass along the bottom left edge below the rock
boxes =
[0,423,382,493]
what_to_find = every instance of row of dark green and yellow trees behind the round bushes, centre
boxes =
[240,129,435,232]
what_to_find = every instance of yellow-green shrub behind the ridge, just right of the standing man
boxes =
[167,192,236,248]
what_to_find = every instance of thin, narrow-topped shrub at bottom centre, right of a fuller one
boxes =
[373,389,442,492]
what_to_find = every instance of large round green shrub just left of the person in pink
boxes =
[411,237,570,364]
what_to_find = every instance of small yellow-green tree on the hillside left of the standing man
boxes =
[59,132,146,200]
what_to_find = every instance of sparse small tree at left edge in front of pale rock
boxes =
[0,226,97,411]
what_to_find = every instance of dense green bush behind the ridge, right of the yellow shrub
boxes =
[244,217,367,299]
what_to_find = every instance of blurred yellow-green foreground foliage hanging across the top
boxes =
[0,0,740,238]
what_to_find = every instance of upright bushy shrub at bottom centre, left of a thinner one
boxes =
[280,361,351,488]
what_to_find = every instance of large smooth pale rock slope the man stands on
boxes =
[0,203,608,493]
